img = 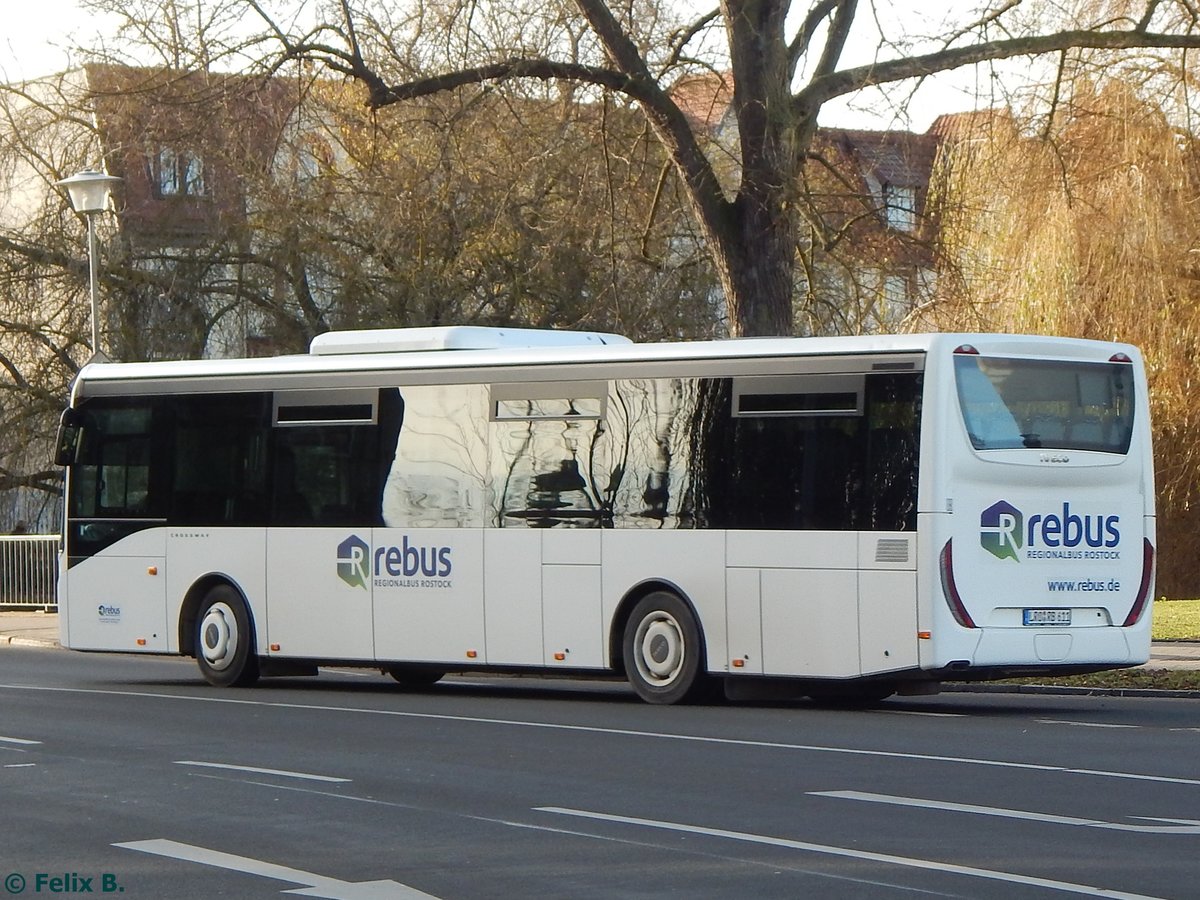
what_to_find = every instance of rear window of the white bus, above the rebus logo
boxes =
[954,355,1134,454]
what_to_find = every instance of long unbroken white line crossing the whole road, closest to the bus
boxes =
[0,684,1200,787]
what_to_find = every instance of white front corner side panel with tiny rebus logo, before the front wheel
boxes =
[59,528,168,653]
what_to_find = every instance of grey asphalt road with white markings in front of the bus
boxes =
[0,648,1200,900]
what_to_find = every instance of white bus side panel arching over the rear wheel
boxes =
[602,528,728,672]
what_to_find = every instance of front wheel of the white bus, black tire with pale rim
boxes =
[188,577,259,688]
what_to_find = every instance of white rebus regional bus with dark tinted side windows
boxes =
[58,328,1154,703]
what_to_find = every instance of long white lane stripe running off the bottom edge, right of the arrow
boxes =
[535,806,1157,900]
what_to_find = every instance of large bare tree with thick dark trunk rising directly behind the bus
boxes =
[245,0,1200,335]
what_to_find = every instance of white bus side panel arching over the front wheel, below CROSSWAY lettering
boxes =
[167,527,269,655]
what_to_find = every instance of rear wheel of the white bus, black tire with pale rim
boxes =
[622,590,709,704]
